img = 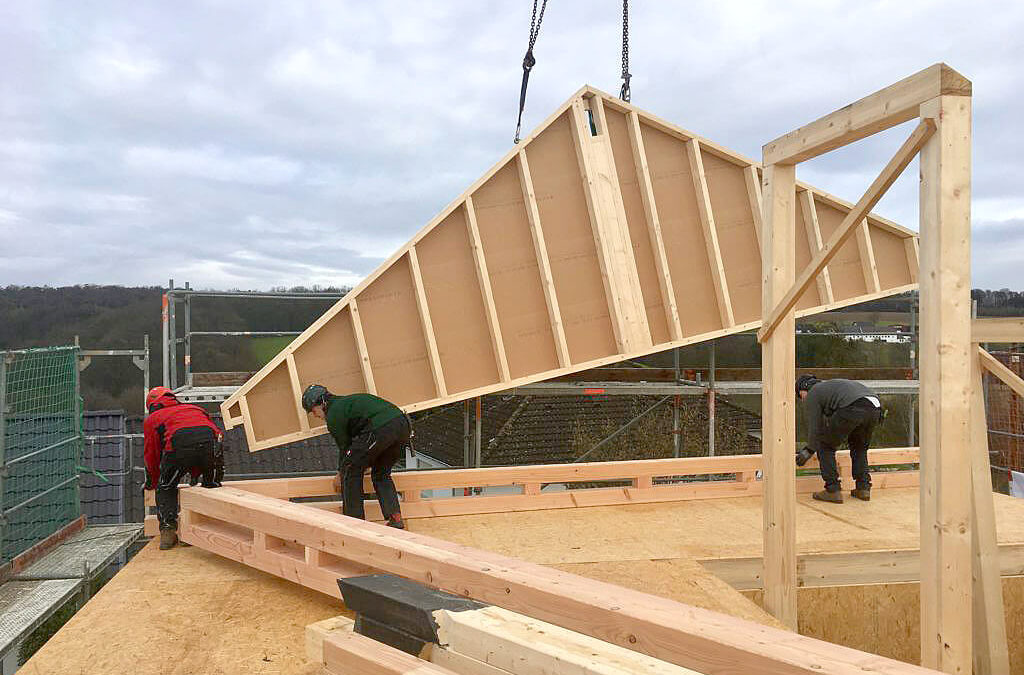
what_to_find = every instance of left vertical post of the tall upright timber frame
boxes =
[761,165,797,630]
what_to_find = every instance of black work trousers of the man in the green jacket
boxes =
[339,415,410,520]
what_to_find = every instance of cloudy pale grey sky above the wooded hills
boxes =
[0,0,1024,290]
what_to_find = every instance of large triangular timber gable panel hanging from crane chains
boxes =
[222,87,918,450]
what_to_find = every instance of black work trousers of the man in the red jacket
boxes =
[157,426,224,530]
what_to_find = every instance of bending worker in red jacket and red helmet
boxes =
[142,387,224,550]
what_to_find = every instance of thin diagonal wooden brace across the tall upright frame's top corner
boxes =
[758,118,936,341]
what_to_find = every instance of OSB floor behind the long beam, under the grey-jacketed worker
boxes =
[410,488,1024,564]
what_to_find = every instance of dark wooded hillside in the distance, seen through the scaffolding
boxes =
[0,286,1024,413]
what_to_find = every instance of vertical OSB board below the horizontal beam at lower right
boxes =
[743,577,1024,673]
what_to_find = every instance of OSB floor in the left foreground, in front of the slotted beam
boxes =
[19,541,351,675]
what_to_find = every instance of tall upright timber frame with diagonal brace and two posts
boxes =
[759,64,1020,673]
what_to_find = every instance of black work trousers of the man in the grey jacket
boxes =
[817,398,882,492]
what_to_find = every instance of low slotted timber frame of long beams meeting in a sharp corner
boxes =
[155,449,934,675]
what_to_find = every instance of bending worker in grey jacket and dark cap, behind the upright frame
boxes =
[797,375,883,504]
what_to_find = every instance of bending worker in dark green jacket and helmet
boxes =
[302,384,412,530]
